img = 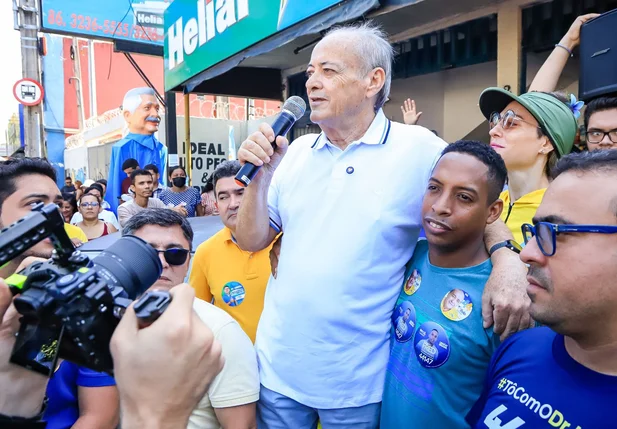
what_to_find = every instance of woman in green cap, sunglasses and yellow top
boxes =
[480,88,580,244]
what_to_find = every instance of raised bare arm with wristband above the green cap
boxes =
[529,13,599,92]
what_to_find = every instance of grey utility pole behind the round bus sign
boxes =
[18,0,46,157]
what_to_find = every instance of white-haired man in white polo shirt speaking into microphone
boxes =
[235,23,530,429]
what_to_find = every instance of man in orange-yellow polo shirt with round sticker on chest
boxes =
[189,161,270,342]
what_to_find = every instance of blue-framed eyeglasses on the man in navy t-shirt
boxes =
[521,222,617,256]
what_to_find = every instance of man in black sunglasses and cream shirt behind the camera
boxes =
[122,208,259,429]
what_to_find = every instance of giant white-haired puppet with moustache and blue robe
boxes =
[105,88,167,212]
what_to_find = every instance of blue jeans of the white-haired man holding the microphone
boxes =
[257,386,381,429]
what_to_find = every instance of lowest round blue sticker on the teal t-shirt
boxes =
[413,322,450,368]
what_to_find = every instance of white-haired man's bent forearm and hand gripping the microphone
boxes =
[235,123,288,252]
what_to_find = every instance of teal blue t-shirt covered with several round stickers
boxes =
[380,240,499,429]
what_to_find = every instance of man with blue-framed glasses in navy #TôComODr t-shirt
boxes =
[467,150,617,429]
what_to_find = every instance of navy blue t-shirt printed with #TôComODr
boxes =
[467,327,617,429]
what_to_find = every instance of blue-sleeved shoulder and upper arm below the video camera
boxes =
[43,361,119,429]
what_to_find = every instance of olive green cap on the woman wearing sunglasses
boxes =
[480,88,578,158]
